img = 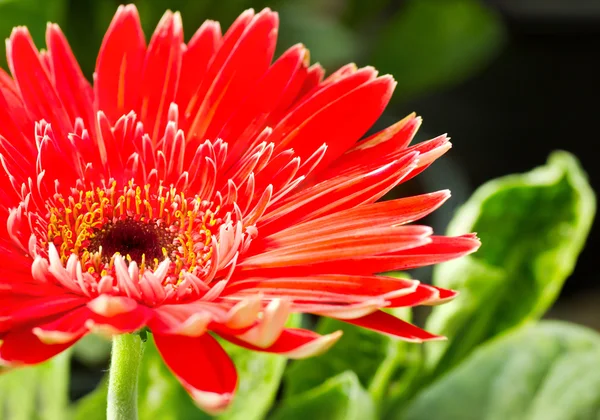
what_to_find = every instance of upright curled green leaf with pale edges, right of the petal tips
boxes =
[427,152,595,373]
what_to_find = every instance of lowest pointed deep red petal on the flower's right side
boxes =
[343,311,446,343]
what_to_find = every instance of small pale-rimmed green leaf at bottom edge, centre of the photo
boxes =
[269,371,377,420]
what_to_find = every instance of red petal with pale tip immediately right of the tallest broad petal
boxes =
[138,11,183,143]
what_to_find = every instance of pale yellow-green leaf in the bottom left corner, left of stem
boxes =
[0,351,71,420]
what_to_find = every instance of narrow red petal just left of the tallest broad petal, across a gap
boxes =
[46,23,94,130]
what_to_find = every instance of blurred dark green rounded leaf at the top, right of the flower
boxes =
[371,0,504,100]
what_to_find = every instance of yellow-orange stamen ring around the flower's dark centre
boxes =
[39,182,232,284]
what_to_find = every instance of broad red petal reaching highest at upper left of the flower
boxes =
[94,4,146,123]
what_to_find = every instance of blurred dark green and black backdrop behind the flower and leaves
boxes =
[0,0,600,404]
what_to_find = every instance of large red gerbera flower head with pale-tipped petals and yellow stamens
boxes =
[0,5,479,411]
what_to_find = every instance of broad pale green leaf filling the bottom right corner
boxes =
[391,321,600,420]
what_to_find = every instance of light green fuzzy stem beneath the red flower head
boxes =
[106,334,144,420]
